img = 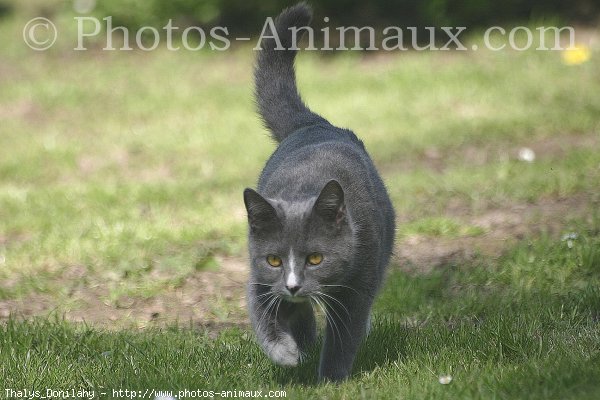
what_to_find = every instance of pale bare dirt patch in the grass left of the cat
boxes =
[0,257,247,330]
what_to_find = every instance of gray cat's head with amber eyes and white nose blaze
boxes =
[244,181,354,302]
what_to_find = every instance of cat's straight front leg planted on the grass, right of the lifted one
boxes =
[319,295,373,381]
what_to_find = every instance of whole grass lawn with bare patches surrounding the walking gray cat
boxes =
[0,11,600,399]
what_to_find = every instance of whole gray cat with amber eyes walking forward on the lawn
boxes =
[244,3,395,381]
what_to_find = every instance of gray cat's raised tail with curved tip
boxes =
[254,2,327,142]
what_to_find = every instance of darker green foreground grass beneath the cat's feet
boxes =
[0,220,600,399]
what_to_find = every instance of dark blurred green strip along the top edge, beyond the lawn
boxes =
[0,0,600,34]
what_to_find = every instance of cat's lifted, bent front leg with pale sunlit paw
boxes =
[248,293,316,367]
